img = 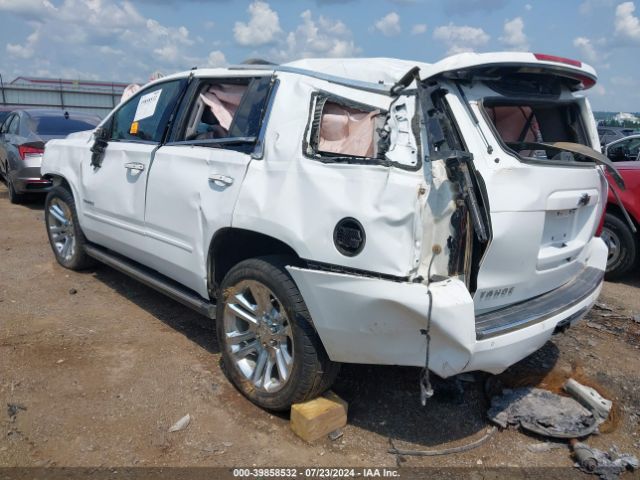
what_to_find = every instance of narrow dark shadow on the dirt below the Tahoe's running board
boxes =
[93,265,220,353]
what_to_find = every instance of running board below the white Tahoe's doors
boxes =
[84,245,216,320]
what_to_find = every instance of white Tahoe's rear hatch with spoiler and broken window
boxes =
[418,54,606,315]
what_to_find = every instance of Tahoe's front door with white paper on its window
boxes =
[81,79,187,263]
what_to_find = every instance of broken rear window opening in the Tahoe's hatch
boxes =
[483,99,587,161]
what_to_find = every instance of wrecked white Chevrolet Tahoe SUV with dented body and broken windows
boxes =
[42,52,621,410]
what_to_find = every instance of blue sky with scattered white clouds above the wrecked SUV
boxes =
[0,0,640,111]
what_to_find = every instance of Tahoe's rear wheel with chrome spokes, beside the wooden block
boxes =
[216,257,339,410]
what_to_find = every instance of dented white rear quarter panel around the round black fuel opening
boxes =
[233,73,428,277]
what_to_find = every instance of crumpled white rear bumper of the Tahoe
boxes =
[288,239,606,377]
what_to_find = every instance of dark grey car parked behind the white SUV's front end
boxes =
[0,109,100,203]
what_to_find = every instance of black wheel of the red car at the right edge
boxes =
[601,213,638,280]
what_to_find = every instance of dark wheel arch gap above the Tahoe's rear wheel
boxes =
[207,227,300,298]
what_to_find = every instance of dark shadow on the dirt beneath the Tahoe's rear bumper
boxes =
[334,342,559,448]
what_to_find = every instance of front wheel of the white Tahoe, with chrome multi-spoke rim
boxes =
[44,186,94,270]
